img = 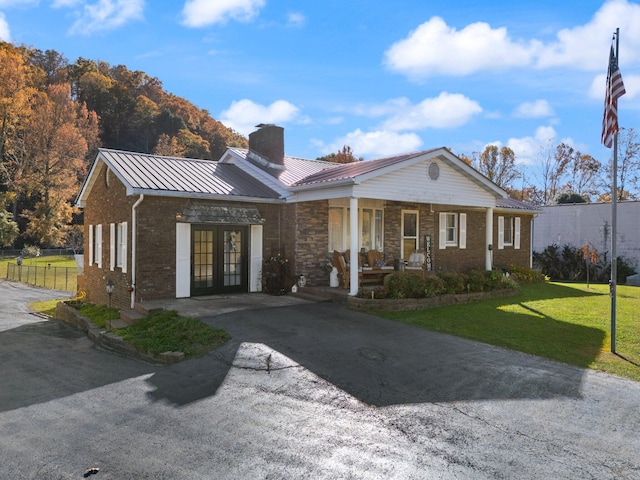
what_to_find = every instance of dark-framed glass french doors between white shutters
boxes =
[191,225,249,295]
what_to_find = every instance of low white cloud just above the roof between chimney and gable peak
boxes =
[324,129,422,158]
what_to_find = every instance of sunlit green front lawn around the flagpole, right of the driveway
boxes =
[378,283,640,381]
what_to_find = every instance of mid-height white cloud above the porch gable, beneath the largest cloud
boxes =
[384,92,482,131]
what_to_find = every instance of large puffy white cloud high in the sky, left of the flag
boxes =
[385,17,537,79]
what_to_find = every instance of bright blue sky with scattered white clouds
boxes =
[0,0,640,176]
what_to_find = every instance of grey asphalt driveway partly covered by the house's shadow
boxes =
[0,282,640,480]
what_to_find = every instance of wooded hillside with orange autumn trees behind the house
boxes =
[0,42,247,248]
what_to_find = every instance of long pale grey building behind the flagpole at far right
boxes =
[533,201,640,266]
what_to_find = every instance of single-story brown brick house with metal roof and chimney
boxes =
[77,125,537,308]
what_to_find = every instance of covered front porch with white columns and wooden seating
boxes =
[328,197,494,296]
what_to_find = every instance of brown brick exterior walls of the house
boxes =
[84,161,531,309]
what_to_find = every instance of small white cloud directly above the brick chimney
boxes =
[220,98,299,135]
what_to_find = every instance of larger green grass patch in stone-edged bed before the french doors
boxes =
[115,310,231,358]
